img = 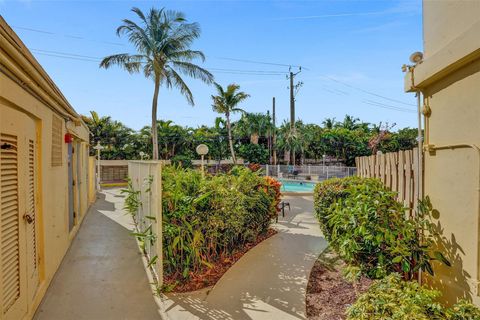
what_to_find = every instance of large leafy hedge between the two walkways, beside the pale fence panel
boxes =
[162,166,279,280]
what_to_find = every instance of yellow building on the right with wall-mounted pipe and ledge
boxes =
[405,0,480,305]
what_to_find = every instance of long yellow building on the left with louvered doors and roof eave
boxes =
[0,16,93,320]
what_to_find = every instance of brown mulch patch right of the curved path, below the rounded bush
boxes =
[306,256,372,320]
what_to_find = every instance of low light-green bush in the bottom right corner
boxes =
[347,274,480,320]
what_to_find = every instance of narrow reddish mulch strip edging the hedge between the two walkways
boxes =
[163,229,277,292]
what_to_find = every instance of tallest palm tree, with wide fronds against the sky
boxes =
[100,8,213,160]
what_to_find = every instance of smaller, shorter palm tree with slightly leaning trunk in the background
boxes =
[212,83,249,163]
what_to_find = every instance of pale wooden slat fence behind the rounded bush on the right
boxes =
[355,148,423,213]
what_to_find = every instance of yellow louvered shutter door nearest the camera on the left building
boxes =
[0,105,35,320]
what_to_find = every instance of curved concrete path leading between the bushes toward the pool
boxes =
[163,197,327,320]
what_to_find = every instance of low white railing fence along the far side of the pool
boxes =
[262,164,357,181]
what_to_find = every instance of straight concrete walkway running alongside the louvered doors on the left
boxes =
[35,189,160,320]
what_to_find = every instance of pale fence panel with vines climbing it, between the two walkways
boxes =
[128,161,163,286]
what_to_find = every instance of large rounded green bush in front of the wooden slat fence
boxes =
[315,177,449,279]
